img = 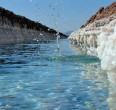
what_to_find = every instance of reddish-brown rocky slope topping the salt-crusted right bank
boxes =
[81,2,116,28]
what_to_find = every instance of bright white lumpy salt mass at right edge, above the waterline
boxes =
[97,27,116,73]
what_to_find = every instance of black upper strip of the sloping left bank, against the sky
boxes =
[0,7,65,36]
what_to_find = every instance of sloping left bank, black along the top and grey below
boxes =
[0,7,67,44]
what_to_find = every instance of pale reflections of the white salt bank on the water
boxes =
[71,41,116,110]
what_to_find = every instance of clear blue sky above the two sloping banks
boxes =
[0,0,115,33]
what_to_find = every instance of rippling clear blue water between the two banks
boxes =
[0,40,110,110]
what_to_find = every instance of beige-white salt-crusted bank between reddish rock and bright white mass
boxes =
[69,15,116,56]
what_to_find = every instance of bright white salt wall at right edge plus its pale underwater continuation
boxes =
[97,27,116,110]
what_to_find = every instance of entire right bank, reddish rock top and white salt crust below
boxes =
[69,2,116,74]
